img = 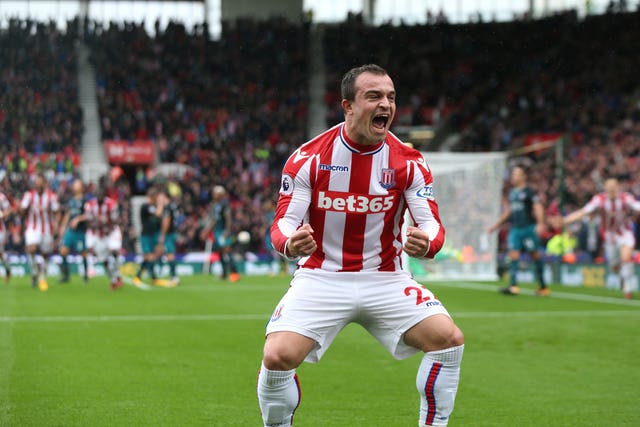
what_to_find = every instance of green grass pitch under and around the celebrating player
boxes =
[0,276,640,427]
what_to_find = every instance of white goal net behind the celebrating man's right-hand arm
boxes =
[405,152,507,280]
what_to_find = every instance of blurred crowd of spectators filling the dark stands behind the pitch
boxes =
[0,9,640,264]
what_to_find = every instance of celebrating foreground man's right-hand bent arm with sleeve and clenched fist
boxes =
[402,157,445,258]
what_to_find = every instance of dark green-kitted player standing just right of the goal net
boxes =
[487,166,550,296]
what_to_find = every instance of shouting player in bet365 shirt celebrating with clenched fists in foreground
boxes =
[257,65,464,426]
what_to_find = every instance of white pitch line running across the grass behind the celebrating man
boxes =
[0,310,640,324]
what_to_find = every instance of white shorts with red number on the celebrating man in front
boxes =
[266,268,449,363]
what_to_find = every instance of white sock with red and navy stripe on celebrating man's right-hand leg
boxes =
[416,345,464,426]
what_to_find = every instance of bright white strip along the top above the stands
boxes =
[0,0,620,35]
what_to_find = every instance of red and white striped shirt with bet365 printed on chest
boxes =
[271,124,444,271]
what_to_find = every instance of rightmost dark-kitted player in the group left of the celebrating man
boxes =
[202,185,240,282]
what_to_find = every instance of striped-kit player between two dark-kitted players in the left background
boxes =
[84,185,122,290]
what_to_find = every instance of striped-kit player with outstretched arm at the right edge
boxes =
[563,178,640,299]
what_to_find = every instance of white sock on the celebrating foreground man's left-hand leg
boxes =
[258,364,300,427]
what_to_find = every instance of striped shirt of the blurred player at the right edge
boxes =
[584,192,640,240]
